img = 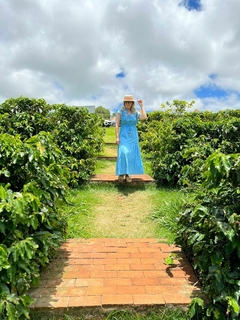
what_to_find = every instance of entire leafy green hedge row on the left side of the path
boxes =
[0,97,103,320]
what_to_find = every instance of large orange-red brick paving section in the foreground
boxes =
[29,238,200,310]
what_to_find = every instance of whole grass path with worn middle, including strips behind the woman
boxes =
[59,127,185,242]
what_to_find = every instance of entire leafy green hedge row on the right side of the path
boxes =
[140,101,240,320]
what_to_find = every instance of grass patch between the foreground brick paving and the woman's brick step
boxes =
[60,184,186,243]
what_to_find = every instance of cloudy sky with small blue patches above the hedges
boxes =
[0,0,240,111]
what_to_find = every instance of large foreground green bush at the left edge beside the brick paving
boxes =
[0,133,70,319]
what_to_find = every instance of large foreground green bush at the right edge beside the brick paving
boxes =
[176,151,240,320]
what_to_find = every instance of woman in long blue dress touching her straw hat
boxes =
[116,96,147,182]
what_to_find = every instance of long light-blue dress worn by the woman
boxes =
[116,110,144,175]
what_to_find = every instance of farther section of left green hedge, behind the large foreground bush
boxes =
[0,97,104,186]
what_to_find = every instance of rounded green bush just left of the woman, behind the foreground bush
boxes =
[51,105,104,183]
